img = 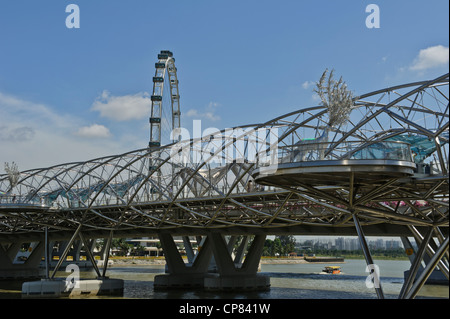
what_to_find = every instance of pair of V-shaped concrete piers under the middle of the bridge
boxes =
[154,232,270,291]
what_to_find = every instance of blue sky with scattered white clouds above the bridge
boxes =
[0,0,449,172]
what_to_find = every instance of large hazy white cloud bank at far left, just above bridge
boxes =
[0,92,126,174]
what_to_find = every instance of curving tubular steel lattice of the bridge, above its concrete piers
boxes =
[0,64,449,238]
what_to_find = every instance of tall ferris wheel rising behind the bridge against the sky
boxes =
[148,50,181,149]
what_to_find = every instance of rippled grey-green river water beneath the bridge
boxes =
[0,259,449,299]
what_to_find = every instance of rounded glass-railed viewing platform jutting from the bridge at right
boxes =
[252,141,416,187]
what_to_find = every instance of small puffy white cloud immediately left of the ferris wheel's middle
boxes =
[92,90,152,121]
